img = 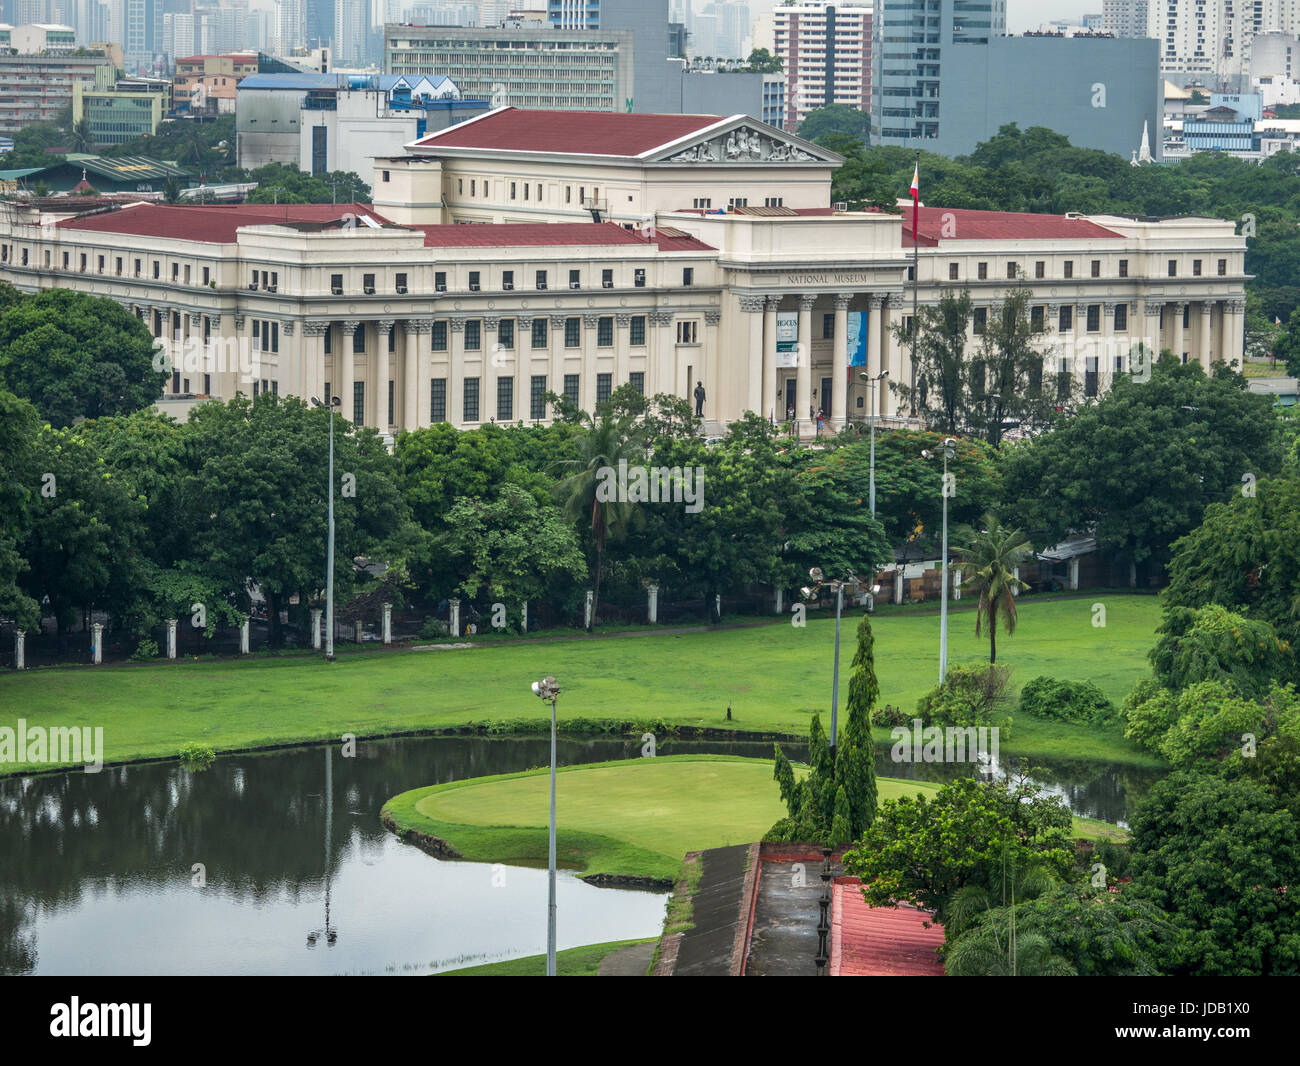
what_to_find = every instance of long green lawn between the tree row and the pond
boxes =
[0,594,1160,772]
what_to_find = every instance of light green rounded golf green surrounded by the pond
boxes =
[384,755,1114,880]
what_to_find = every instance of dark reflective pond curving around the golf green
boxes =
[0,737,1157,975]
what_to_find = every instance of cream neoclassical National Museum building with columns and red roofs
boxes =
[0,108,1245,433]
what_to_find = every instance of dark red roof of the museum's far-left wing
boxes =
[59,204,387,244]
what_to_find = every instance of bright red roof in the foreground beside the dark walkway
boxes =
[831,878,944,978]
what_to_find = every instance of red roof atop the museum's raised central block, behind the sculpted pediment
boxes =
[416,108,725,157]
